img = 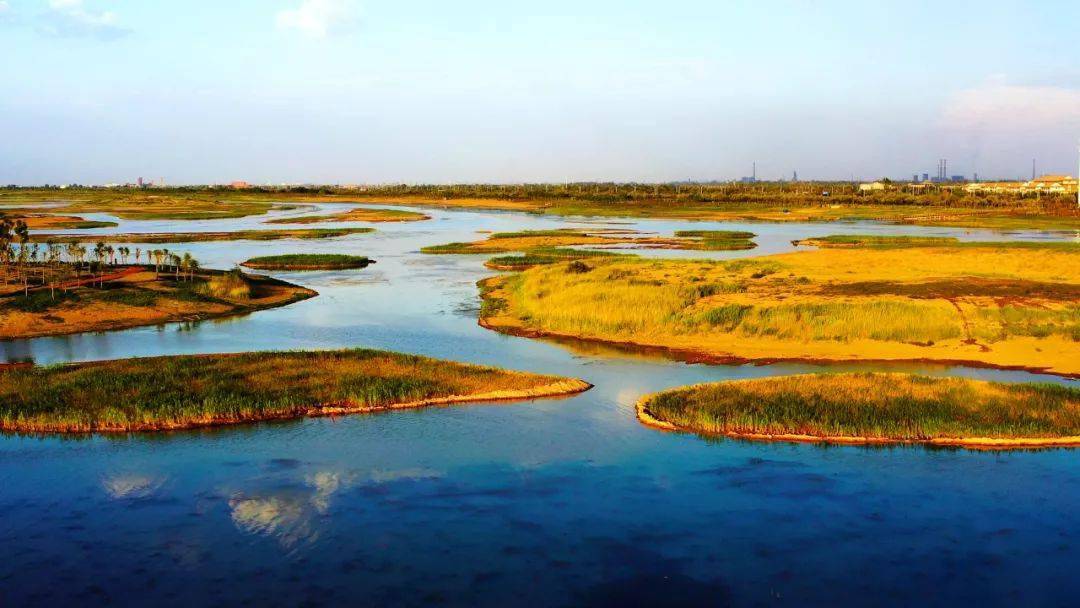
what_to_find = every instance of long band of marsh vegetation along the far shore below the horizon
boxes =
[0,181,1080,230]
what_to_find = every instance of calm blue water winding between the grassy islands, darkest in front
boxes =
[0,205,1080,606]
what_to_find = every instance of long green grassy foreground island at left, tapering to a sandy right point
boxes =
[0,350,590,433]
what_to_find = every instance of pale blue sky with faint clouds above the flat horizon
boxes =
[0,0,1080,185]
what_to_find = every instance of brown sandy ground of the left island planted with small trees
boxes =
[0,267,318,339]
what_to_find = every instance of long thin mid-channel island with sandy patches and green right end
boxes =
[420,228,757,254]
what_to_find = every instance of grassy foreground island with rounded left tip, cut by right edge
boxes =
[637,374,1080,447]
